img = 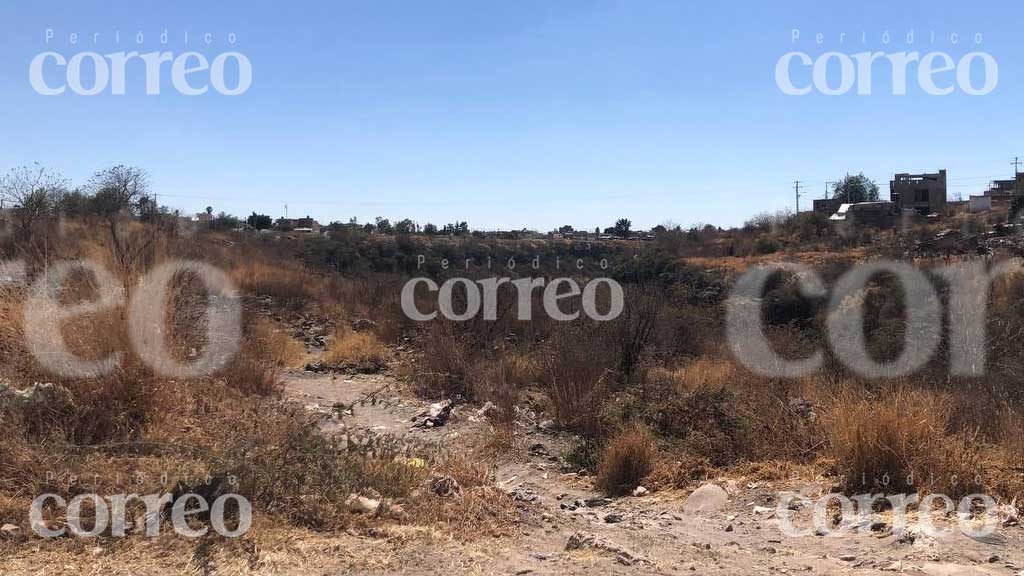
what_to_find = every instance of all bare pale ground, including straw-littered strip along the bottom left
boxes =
[0,358,1024,576]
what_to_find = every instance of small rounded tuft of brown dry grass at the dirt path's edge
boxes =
[597,425,657,496]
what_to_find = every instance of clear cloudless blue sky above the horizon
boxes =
[0,0,1024,230]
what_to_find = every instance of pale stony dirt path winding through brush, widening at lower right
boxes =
[287,364,1024,575]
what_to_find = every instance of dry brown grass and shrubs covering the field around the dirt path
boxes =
[0,158,1024,561]
